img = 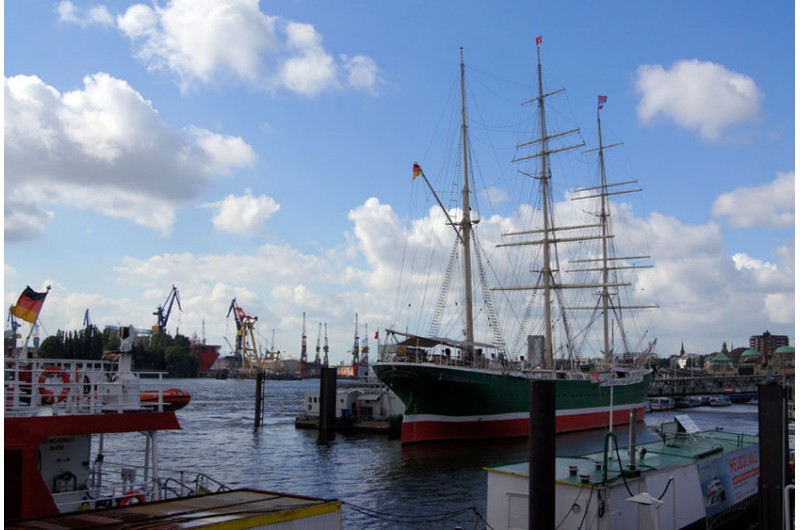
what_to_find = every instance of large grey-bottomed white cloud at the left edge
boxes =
[4,73,256,238]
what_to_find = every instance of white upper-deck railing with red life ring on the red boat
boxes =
[4,358,172,417]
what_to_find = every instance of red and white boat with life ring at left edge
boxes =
[4,353,209,521]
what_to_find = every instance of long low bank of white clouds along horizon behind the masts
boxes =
[6,194,794,362]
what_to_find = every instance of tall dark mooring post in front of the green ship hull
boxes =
[528,380,556,530]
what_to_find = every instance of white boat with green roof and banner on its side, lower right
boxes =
[487,416,760,530]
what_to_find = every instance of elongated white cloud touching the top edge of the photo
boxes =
[117,0,382,97]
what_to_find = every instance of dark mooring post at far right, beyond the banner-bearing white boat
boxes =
[758,380,788,530]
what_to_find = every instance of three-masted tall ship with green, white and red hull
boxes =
[373,44,655,443]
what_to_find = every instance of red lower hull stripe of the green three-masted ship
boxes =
[400,406,644,443]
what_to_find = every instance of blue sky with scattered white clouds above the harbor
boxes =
[3,0,795,363]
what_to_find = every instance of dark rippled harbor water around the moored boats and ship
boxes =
[105,379,758,529]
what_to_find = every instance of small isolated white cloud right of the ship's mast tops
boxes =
[635,59,764,140]
